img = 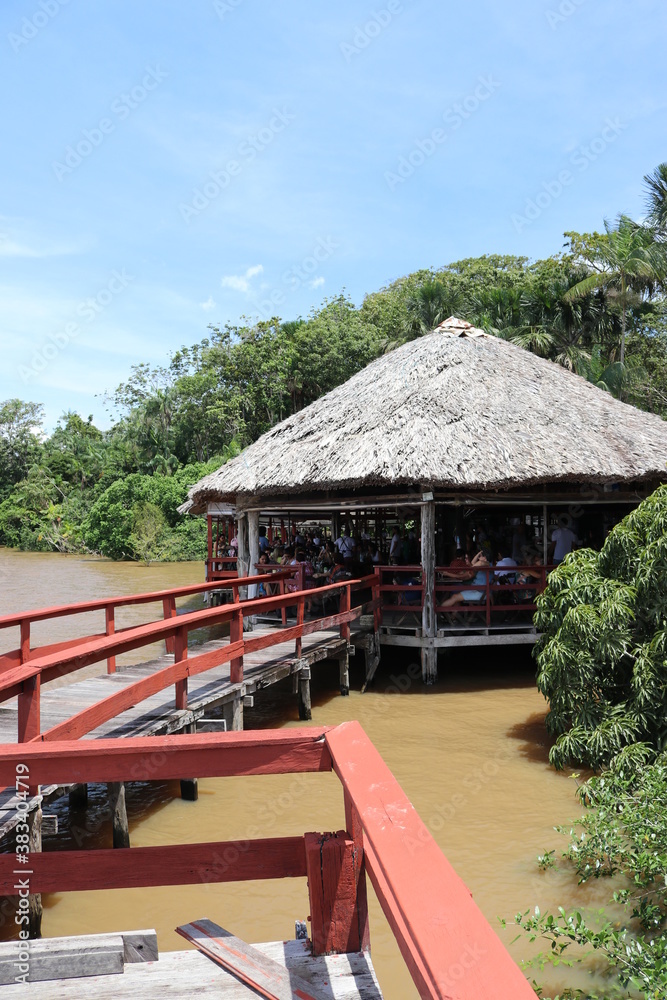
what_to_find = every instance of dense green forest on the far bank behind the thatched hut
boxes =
[0,165,667,558]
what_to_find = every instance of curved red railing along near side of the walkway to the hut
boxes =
[0,571,379,743]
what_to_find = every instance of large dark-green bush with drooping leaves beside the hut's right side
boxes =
[535,486,667,768]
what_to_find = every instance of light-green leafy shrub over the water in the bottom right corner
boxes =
[515,744,667,1000]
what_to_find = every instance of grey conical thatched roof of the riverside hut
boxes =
[186,318,667,511]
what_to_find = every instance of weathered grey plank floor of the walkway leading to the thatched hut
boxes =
[0,622,358,837]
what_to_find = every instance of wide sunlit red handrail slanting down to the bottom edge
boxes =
[326,722,535,1000]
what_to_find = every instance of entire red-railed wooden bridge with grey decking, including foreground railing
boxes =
[0,570,534,1000]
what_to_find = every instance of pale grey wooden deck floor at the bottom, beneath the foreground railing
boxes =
[0,935,382,1000]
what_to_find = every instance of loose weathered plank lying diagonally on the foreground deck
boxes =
[176,918,329,1000]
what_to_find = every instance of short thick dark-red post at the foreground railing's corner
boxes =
[304,830,364,955]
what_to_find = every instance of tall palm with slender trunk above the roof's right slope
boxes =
[564,215,666,365]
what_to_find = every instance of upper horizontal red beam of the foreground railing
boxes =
[0,726,332,785]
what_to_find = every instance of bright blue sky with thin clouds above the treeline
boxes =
[0,0,667,427]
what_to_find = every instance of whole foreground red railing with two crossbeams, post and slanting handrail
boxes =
[0,722,535,1000]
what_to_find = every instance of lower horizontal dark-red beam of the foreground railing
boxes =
[0,837,306,896]
